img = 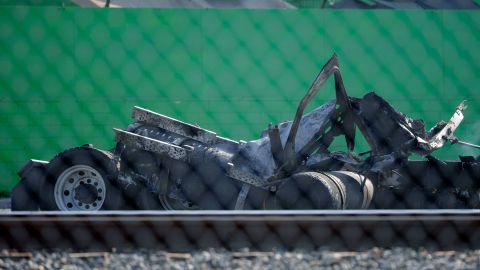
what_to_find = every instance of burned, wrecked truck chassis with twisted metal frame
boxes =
[12,55,480,211]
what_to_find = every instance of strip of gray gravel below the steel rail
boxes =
[0,248,480,270]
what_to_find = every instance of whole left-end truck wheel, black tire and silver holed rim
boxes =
[40,147,123,211]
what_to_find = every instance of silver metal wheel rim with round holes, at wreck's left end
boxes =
[54,165,107,211]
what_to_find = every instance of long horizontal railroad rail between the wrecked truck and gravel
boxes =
[0,210,480,252]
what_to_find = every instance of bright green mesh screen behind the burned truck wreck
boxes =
[0,7,480,191]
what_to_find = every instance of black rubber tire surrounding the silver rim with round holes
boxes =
[40,146,123,211]
